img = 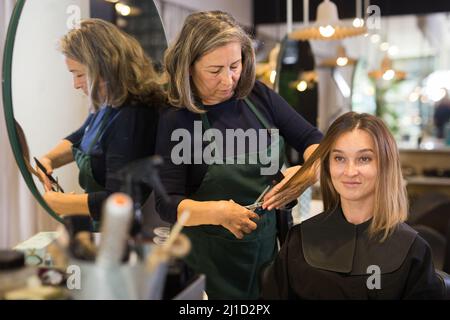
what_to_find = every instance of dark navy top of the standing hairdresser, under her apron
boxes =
[156,81,322,223]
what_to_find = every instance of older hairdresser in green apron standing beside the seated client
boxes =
[157,11,322,299]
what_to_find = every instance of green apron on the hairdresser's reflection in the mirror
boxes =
[72,110,110,232]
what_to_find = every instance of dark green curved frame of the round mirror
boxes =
[2,0,62,223]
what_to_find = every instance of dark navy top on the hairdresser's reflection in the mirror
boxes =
[65,104,159,220]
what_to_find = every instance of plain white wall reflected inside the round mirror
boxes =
[12,0,89,192]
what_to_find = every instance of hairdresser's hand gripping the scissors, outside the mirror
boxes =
[218,200,259,239]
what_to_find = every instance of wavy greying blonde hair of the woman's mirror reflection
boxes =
[59,19,164,110]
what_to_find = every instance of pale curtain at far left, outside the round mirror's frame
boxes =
[0,0,57,248]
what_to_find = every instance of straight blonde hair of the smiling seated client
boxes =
[302,112,408,242]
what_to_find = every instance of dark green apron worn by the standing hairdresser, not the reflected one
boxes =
[183,98,284,299]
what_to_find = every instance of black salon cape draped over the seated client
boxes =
[262,208,443,300]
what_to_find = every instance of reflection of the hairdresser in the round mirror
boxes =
[38,19,165,228]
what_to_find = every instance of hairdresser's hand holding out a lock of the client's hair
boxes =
[262,166,317,210]
